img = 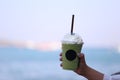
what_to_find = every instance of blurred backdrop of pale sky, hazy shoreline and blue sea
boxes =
[0,0,120,80]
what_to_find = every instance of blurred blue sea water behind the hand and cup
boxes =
[0,47,120,80]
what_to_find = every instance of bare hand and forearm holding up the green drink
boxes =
[60,53,104,80]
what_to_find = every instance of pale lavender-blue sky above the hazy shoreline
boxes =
[0,0,120,46]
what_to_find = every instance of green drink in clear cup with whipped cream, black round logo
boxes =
[62,14,83,70]
